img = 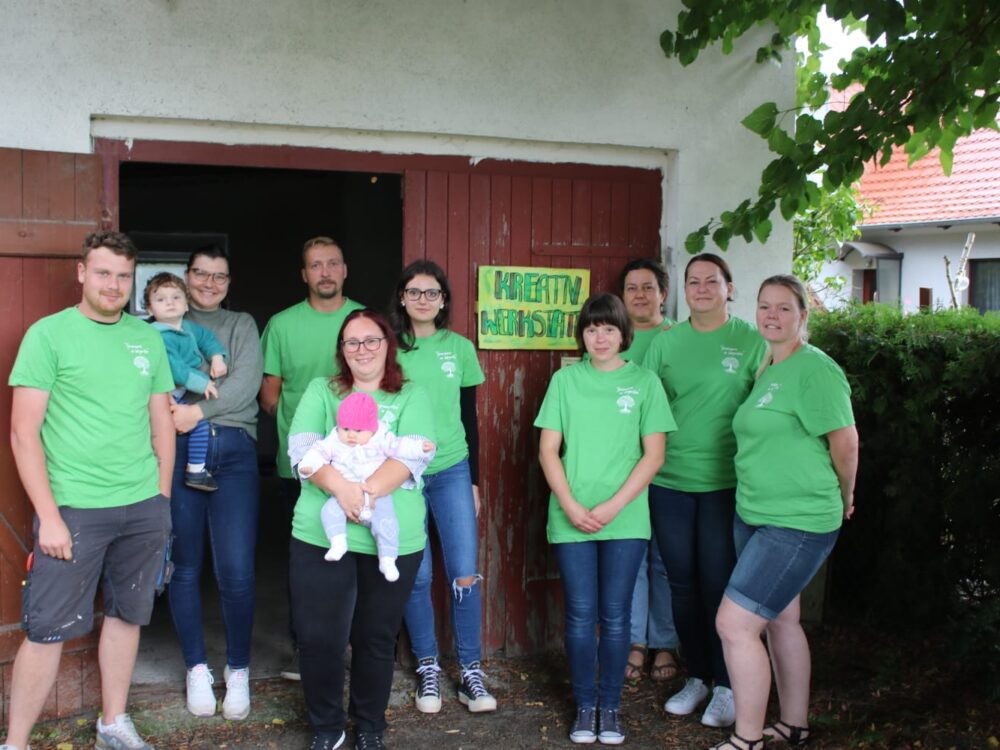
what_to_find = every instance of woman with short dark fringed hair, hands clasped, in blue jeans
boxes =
[535,294,676,745]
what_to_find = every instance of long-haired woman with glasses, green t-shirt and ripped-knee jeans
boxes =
[391,260,497,713]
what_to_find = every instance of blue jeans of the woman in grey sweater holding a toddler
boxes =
[167,424,260,669]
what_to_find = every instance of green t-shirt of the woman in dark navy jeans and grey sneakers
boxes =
[643,317,767,492]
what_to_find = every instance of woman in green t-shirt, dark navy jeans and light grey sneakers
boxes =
[643,253,764,727]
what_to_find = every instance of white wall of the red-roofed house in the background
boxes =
[821,223,1000,312]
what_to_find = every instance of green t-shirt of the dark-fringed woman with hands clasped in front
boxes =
[535,362,677,544]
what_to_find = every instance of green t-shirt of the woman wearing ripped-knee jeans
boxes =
[398,329,486,474]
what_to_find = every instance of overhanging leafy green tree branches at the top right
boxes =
[660,0,1000,252]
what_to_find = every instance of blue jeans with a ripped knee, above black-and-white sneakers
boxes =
[405,459,483,666]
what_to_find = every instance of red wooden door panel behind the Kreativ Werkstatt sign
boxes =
[403,161,661,654]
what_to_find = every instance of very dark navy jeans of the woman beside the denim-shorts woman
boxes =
[649,485,736,687]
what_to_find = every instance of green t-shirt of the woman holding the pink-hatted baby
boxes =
[289,378,436,555]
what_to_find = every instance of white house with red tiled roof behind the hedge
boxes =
[818,125,1000,312]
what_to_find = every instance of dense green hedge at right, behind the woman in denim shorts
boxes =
[810,305,1000,625]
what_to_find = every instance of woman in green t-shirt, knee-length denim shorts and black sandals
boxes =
[713,275,858,750]
